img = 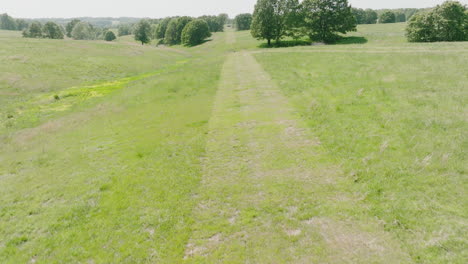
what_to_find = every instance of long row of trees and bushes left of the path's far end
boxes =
[17,14,229,46]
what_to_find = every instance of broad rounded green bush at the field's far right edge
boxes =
[406,1,468,42]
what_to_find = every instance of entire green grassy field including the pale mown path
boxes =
[0,24,468,263]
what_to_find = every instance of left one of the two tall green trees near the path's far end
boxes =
[251,0,299,45]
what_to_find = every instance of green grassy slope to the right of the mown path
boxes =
[256,25,468,263]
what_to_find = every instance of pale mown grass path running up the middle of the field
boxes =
[184,29,408,263]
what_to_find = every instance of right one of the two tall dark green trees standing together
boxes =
[302,0,356,43]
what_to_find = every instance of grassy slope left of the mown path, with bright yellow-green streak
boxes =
[0,32,223,263]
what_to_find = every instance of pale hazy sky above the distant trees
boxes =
[0,0,468,18]
